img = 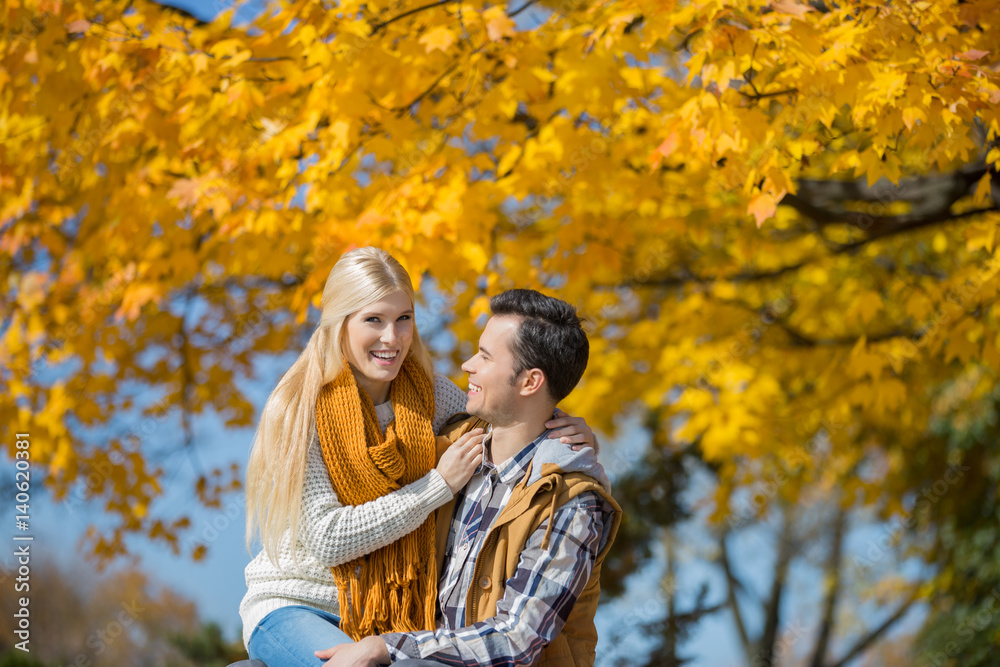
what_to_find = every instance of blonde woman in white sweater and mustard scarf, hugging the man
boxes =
[240,248,593,667]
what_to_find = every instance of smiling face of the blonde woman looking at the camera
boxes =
[344,292,414,405]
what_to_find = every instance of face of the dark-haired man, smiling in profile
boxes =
[462,316,521,426]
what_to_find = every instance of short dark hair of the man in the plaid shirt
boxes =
[490,289,590,403]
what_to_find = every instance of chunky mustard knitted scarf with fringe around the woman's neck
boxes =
[316,357,437,641]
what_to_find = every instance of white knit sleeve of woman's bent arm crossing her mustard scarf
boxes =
[299,437,452,567]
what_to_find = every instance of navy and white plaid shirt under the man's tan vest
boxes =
[382,431,605,665]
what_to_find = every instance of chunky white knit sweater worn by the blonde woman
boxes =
[240,375,466,645]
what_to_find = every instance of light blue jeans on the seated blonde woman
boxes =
[247,605,354,667]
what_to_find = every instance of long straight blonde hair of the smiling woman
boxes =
[246,248,433,563]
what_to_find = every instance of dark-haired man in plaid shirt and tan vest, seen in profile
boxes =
[316,290,621,666]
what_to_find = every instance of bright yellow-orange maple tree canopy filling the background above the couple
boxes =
[0,0,1000,664]
